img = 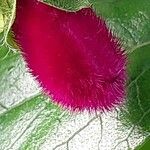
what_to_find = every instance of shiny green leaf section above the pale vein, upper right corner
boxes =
[90,0,150,51]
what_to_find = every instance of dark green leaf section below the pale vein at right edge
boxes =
[120,44,150,132]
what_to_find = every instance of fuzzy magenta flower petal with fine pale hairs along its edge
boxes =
[12,0,126,111]
